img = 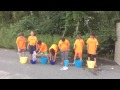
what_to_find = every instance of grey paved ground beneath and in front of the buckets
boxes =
[0,49,120,79]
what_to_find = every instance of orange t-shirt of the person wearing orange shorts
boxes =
[74,39,84,53]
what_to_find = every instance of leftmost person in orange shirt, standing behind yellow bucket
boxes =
[16,33,26,57]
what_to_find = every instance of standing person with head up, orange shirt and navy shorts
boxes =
[27,31,38,60]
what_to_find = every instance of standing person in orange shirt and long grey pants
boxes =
[58,37,70,64]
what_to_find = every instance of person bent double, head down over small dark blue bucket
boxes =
[48,44,58,63]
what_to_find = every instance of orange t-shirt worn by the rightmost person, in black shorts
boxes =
[87,38,98,54]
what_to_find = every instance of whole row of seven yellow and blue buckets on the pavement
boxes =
[20,57,95,68]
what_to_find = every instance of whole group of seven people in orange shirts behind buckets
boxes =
[16,31,98,66]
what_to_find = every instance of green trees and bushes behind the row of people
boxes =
[0,11,120,59]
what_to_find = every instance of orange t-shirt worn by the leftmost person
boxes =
[16,37,26,49]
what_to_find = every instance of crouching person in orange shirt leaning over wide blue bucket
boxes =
[37,41,47,54]
